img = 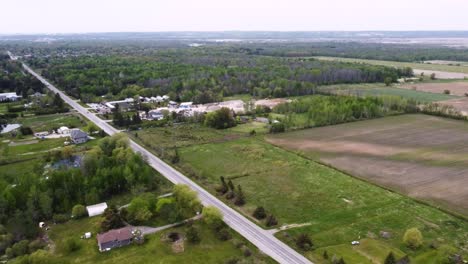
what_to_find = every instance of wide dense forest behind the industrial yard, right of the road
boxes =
[23,48,412,103]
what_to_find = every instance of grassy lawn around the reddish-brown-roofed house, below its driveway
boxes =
[45,217,274,264]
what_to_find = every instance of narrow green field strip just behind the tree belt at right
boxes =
[318,83,458,103]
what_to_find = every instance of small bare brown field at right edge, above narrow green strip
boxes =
[400,82,468,96]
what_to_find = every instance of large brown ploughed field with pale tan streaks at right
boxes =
[267,115,468,215]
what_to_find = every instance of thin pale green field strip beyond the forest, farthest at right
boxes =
[314,57,468,73]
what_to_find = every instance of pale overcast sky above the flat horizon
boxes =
[0,0,468,34]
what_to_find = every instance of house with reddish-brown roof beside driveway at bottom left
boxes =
[97,226,133,252]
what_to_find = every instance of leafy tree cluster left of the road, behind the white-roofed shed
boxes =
[0,135,159,254]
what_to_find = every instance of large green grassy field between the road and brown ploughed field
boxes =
[179,137,468,263]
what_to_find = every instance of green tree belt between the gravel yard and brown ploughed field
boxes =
[273,95,418,130]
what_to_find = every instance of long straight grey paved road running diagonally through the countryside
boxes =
[17,56,311,264]
